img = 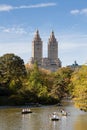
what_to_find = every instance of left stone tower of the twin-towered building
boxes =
[32,30,42,65]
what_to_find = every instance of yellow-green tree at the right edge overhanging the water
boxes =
[71,65,87,111]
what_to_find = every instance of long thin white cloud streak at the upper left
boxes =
[0,3,56,12]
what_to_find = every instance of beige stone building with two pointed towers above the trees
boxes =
[30,30,61,71]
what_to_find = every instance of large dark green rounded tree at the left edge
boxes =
[0,54,26,93]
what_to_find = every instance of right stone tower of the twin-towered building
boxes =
[48,31,58,61]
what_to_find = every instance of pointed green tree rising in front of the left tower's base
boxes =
[27,62,47,102]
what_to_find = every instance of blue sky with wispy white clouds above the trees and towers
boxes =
[0,0,87,66]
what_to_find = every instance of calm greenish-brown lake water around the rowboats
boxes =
[0,102,87,130]
